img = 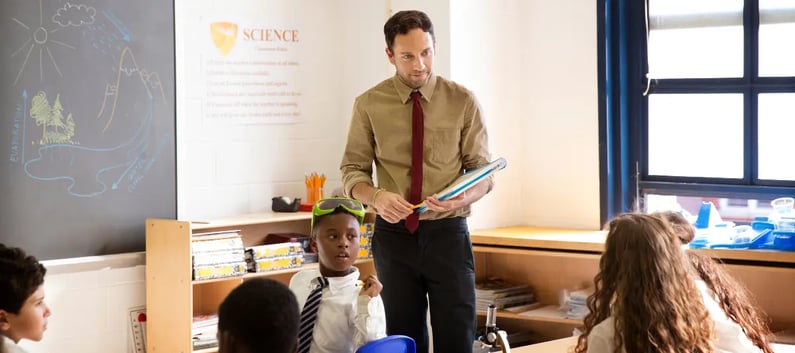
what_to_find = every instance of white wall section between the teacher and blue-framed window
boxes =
[450,0,600,229]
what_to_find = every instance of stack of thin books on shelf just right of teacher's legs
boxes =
[475,278,540,313]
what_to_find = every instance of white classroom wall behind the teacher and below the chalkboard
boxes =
[18,0,599,353]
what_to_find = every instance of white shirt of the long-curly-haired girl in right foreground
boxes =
[588,280,761,353]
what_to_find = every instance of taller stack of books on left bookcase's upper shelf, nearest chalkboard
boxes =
[190,230,246,280]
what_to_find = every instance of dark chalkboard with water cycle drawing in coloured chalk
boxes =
[0,0,176,259]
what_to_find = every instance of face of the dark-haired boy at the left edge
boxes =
[0,286,50,342]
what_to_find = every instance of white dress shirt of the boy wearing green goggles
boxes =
[290,267,386,353]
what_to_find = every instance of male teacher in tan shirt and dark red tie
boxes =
[340,11,493,353]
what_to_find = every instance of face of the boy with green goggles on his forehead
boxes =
[312,213,359,277]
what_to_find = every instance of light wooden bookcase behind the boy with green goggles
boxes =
[146,212,375,353]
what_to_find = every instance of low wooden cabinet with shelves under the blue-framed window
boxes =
[471,227,795,340]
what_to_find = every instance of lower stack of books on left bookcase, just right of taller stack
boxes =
[246,241,304,272]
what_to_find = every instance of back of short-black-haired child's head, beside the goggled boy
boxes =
[218,278,298,353]
